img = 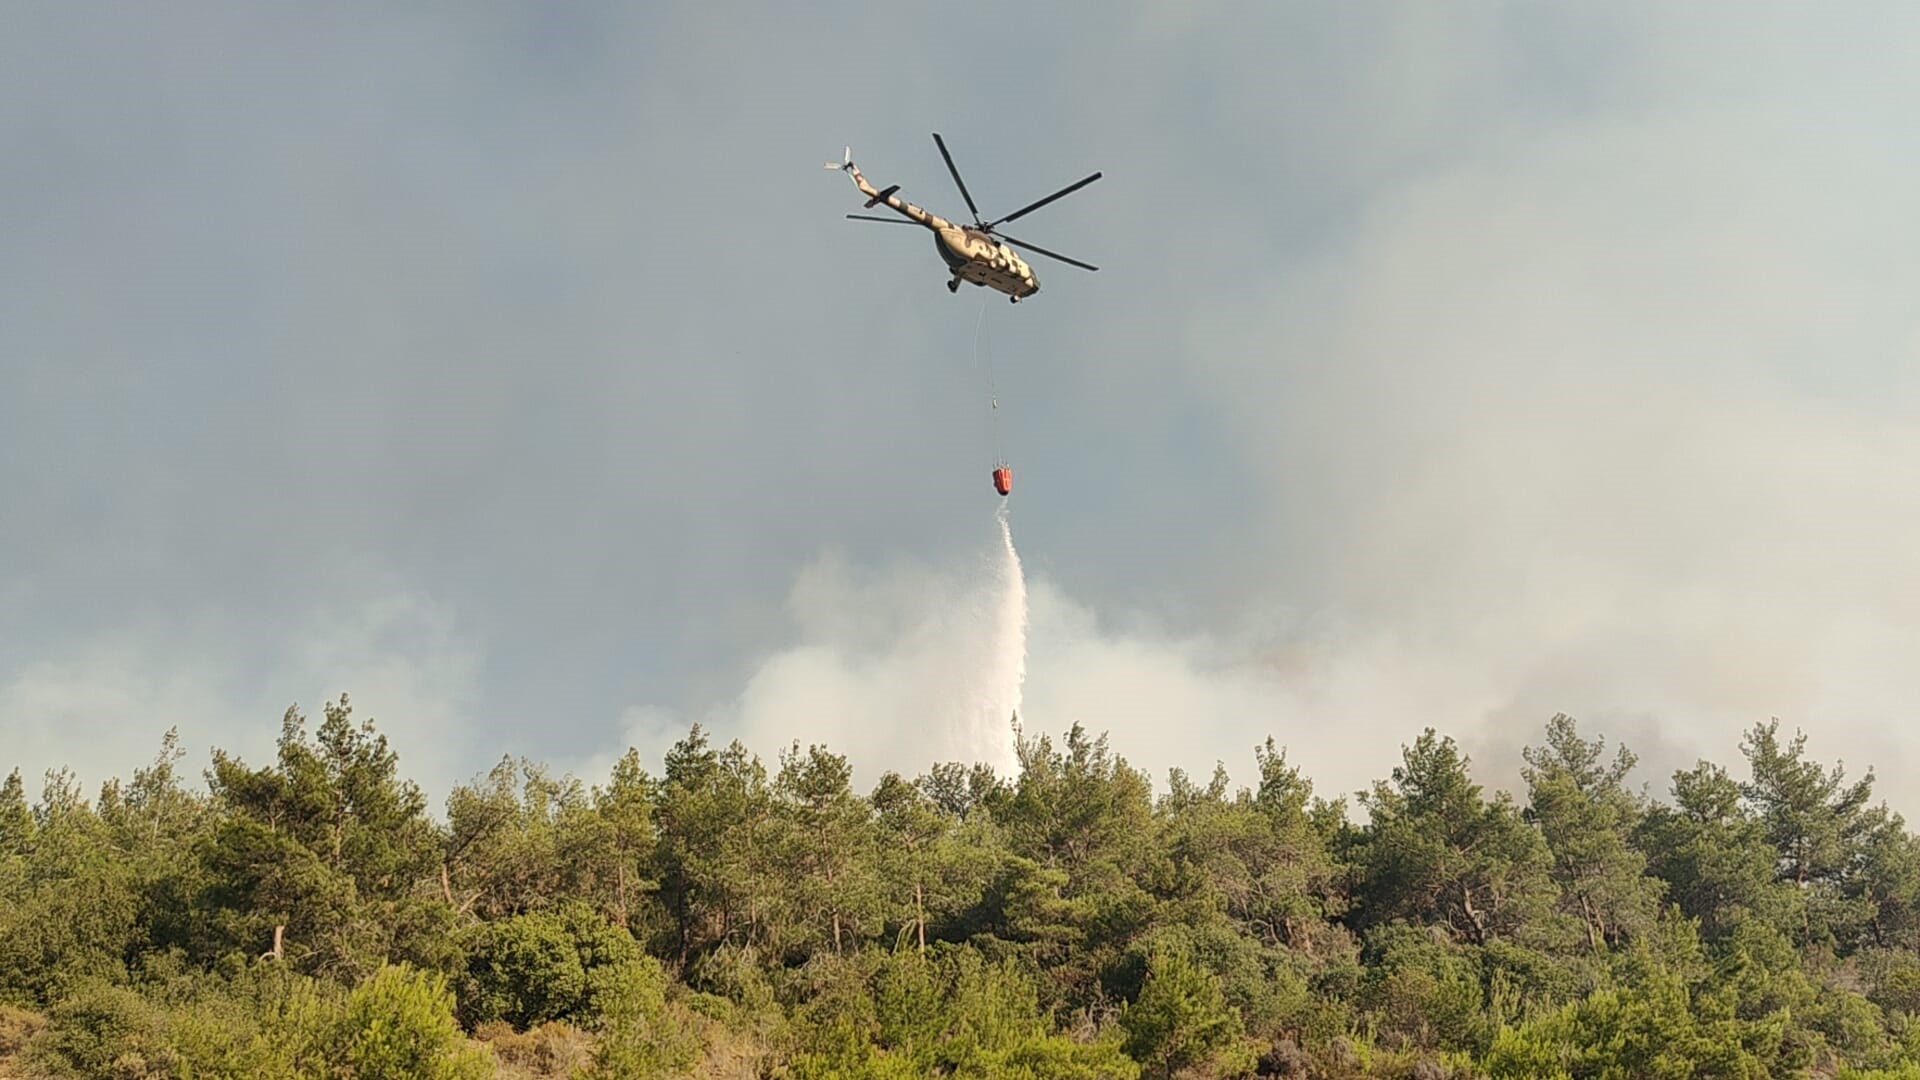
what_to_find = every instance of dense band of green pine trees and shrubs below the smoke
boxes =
[0,698,1920,1080]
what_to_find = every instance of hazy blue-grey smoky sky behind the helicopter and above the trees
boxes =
[0,0,1920,813]
